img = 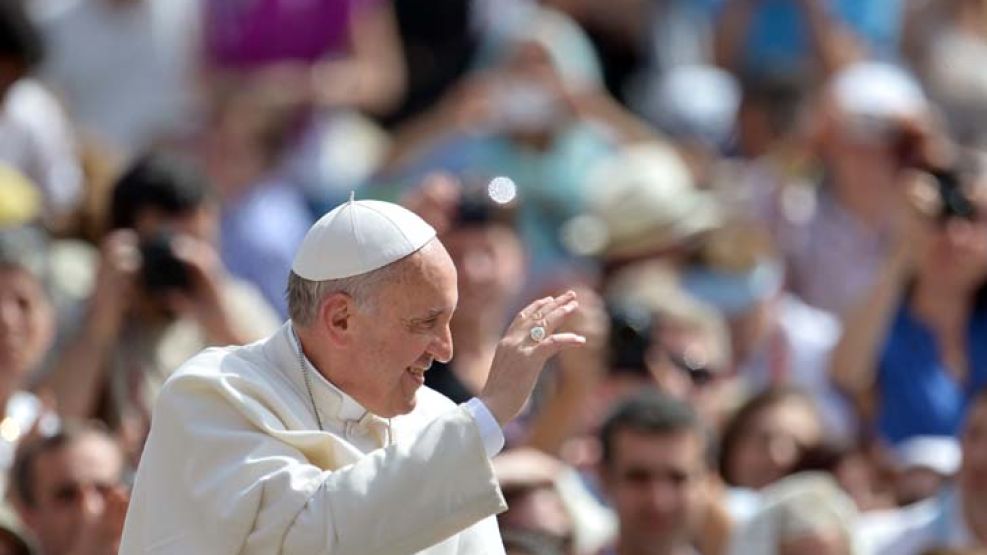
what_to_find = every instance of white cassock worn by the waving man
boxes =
[120,323,507,555]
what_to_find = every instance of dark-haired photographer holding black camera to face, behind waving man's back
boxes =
[46,153,277,464]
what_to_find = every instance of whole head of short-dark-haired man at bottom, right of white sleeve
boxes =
[601,392,708,555]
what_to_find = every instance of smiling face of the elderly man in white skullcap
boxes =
[346,240,458,418]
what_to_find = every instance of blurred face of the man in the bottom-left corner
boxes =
[24,434,123,555]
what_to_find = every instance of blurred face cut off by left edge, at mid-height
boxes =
[0,267,55,387]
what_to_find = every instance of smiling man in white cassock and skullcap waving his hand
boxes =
[120,194,584,555]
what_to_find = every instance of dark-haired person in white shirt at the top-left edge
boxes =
[0,0,82,223]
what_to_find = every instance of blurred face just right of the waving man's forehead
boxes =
[442,224,524,324]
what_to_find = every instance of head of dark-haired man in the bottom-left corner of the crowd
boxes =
[13,423,128,555]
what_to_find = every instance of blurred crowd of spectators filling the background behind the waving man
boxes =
[0,0,987,555]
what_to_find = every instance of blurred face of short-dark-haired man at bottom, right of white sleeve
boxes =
[604,429,706,553]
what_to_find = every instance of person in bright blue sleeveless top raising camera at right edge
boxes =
[830,154,987,450]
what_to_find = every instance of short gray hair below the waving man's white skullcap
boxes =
[285,259,404,326]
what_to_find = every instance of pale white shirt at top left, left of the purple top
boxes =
[32,0,200,157]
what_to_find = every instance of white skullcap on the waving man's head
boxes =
[291,195,435,281]
